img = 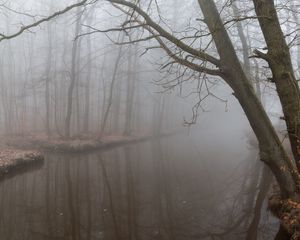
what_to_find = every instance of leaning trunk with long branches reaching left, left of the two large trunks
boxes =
[198,0,299,197]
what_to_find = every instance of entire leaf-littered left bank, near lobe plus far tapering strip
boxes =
[0,133,172,181]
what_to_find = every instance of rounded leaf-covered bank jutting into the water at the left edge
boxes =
[0,149,44,181]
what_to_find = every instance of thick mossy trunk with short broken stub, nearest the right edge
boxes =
[253,0,300,170]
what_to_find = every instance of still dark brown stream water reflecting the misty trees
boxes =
[0,138,278,240]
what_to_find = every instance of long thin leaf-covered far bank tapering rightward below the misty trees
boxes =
[6,135,162,153]
